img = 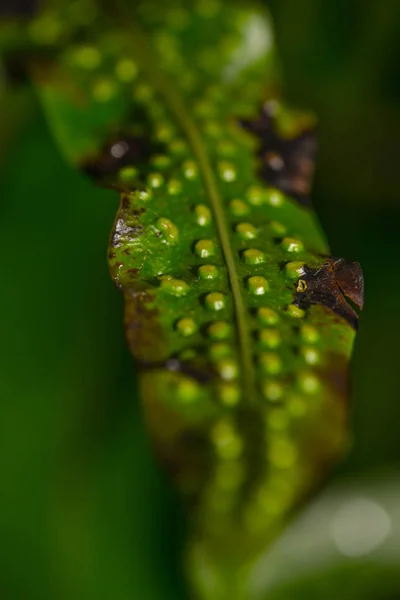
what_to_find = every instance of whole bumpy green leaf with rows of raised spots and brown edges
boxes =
[1,0,363,600]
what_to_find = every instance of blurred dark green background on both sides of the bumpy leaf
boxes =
[0,0,400,600]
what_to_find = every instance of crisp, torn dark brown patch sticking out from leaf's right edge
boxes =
[294,258,364,329]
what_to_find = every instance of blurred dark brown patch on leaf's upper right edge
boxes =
[241,103,317,206]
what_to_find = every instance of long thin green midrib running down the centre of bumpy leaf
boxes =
[132,27,256,403]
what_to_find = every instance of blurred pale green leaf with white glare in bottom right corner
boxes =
[252,471,400,600]
